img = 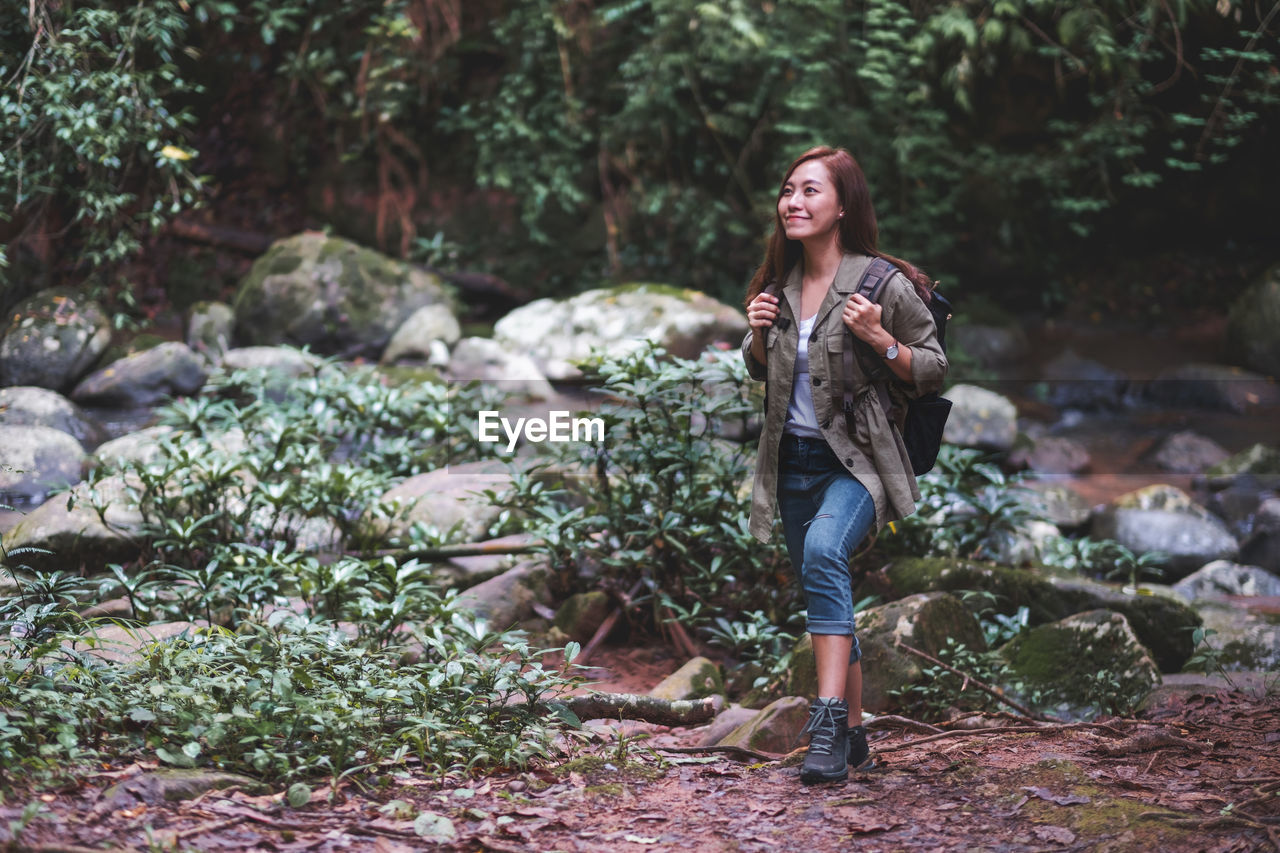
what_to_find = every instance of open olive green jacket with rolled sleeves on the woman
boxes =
[742,255,947,542]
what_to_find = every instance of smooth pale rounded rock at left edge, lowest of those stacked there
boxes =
[0,427,84,505]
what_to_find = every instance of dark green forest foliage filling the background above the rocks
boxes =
[0,0,1280,308]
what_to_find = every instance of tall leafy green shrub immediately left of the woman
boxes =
[492,343,795,666]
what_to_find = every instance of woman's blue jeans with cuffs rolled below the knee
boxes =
[778,434,876,663]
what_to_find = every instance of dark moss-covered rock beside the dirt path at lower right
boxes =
[1000,610,1160,717]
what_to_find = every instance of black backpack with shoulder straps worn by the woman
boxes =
[835,257,951,476]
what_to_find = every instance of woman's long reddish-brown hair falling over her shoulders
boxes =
[744,145,934,306]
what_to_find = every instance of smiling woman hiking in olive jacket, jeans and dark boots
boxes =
[742,147,947,784]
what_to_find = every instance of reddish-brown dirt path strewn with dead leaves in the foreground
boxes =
[10,649,1280,853]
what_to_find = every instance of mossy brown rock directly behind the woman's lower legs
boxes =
[787,592,986,713]
